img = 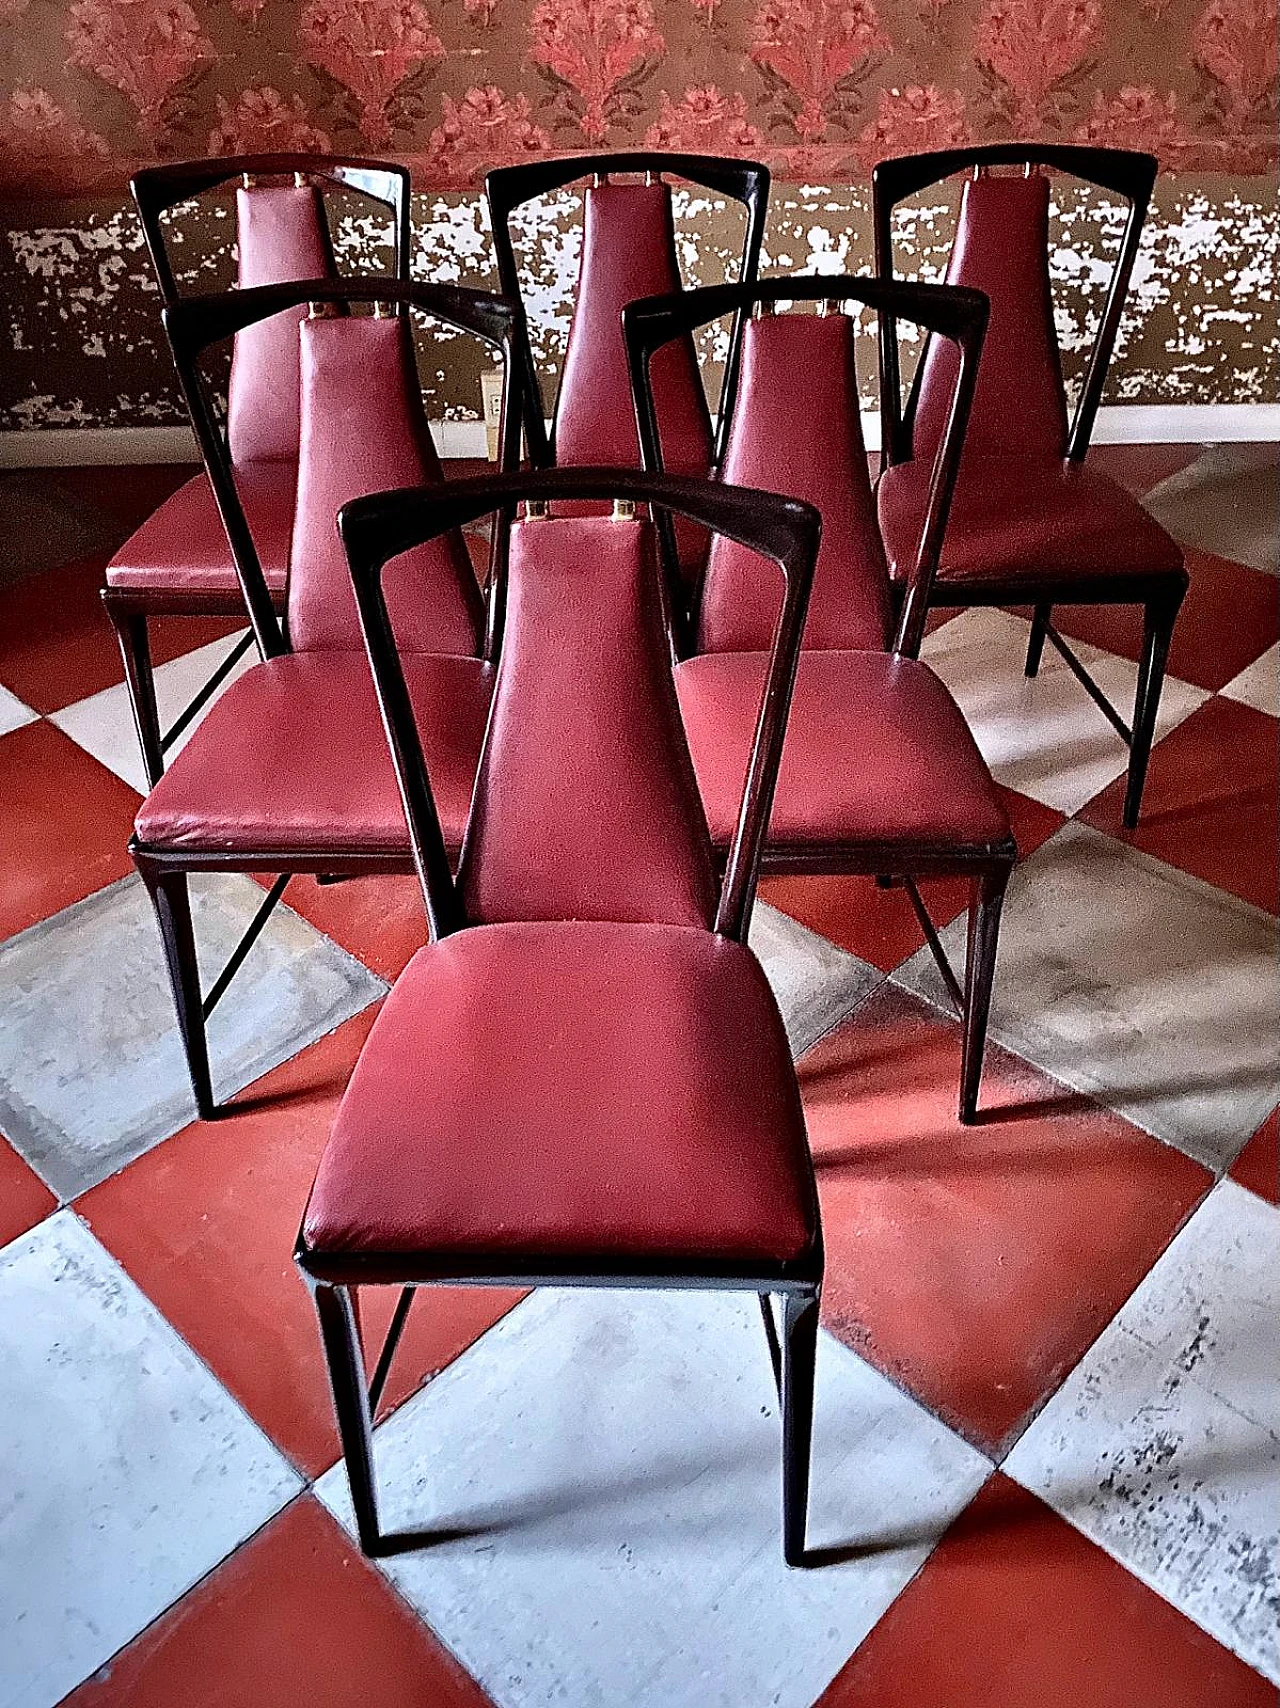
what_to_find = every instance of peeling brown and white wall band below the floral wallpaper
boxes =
[0,174,1280,430]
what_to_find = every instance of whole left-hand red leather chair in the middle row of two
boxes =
[130,280,520,1119]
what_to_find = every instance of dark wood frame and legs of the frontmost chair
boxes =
[294,468,822,1565]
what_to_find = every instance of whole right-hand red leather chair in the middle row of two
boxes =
[624,269,1017,1120]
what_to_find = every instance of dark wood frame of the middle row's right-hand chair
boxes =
[622,277,1017,1122]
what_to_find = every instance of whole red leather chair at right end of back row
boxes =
[873,142,1188,828]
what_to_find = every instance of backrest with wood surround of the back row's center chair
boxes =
[485,152,769,475]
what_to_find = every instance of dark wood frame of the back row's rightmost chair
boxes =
[872,142,1189,830]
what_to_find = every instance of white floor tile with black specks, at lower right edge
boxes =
[1005,1180,1280,1682]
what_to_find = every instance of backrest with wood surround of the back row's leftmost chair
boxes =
[130,154,410,463]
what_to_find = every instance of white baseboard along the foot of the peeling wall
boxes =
[0,403,1280,468]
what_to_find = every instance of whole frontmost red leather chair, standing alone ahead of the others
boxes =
[296,468,822,1565]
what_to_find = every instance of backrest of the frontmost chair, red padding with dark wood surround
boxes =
[340,468,822,941]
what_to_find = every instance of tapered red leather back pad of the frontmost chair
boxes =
[461,516,716,926]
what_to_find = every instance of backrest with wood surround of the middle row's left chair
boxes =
[164,280,520,658]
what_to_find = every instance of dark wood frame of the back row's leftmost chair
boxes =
[103,154,412,784]
